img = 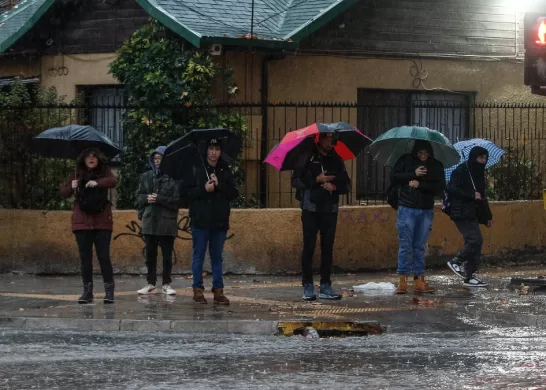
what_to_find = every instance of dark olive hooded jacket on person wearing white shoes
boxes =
[137,146,180,236]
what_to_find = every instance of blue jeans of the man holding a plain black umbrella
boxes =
[191,227,227,288]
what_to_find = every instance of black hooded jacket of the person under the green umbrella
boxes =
[391,140,445,209]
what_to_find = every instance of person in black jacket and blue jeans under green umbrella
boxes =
[391,140,445,294]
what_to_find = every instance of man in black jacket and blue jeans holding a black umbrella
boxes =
[182,139,239,305]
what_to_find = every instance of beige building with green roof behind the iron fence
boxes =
[0,0,546,207]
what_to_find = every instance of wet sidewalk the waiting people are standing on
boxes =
[0,267,546,334]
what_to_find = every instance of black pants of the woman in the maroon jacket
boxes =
[74,230,114,284]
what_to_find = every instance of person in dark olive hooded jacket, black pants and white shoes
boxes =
[137,146,180,295]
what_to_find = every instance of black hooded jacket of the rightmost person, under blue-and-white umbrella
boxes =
[447,163,493,225]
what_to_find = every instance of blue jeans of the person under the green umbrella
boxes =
[396,206,434,276]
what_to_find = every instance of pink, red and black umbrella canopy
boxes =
[265,122,372,171]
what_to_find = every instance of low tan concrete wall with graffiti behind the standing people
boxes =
[0,201,546,274]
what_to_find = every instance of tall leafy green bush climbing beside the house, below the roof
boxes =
[110,21,260,209]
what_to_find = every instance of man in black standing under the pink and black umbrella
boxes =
[292,133,351,301]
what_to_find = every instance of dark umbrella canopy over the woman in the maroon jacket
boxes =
[31,125,120,159]
